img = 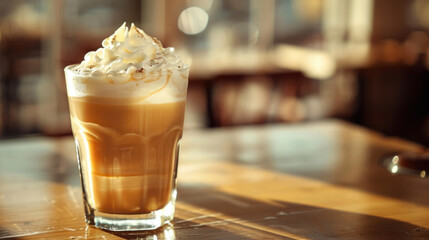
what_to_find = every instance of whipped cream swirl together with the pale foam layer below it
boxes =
[65,23,189,103]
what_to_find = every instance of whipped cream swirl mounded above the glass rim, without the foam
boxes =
[75,23,187,74]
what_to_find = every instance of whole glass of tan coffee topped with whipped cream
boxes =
[65,23,189,231]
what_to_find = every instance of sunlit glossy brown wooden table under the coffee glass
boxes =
[0,120,429,239]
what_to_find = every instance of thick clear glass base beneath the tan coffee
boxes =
[84,191,176,231]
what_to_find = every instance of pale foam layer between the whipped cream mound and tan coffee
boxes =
[65,66,188,103]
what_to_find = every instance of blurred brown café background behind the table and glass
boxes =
[0,0,429,146]
